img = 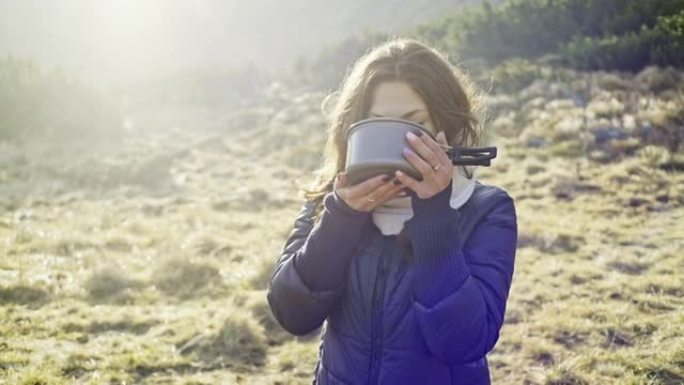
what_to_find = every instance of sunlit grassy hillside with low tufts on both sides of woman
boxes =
[0,64,684,385]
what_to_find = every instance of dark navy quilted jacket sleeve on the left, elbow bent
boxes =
[267,191,372,335]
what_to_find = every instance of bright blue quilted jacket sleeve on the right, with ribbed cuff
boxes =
[406,182,517,364]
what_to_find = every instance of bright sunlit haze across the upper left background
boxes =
[0,0,480,87]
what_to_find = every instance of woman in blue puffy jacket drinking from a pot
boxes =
[268,39,517,385]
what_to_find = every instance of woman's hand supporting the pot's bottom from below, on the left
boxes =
[334,172,406,212]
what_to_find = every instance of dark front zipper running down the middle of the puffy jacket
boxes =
[368,238,388,385]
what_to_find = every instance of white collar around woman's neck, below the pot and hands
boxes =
[373,166,476,235]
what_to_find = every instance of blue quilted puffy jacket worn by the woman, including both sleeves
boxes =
[267,181,517,385]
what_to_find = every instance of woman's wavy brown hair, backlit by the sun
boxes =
[300,38,482,223]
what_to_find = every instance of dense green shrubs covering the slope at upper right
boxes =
[416,0,684,70]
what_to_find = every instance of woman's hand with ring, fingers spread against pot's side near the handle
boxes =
[395,131,454,199]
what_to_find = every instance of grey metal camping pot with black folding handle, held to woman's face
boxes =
[345,118,496,185]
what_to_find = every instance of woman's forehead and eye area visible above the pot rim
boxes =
[368,80,437,135]
